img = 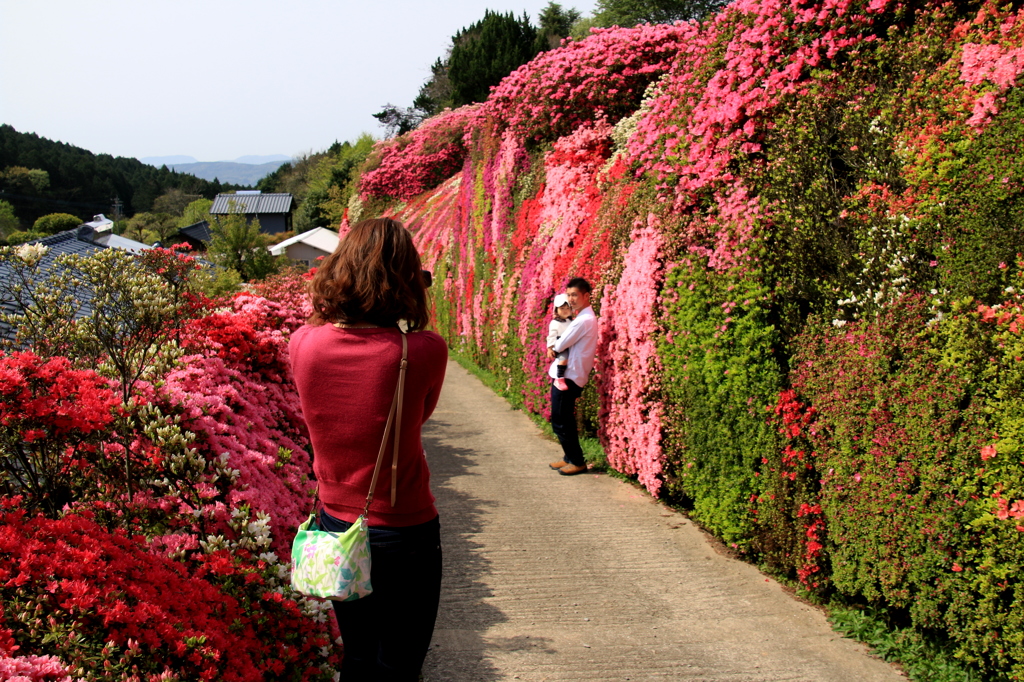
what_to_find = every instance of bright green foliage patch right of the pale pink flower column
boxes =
[659,260,782,547]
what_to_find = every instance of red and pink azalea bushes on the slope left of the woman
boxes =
[0,247,339,681]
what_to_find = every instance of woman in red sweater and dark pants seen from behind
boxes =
[290,218,447,681]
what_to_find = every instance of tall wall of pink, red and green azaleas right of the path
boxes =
[361,0,1024,667]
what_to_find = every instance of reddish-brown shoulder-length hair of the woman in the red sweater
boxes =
[309,218,430,332]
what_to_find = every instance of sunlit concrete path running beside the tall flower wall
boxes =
[424,361,905,682]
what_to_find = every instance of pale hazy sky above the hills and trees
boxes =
[0,0,595,161]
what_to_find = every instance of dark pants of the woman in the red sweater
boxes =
[321,511,441,682]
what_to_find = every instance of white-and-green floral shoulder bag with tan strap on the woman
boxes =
[292,332,409,601]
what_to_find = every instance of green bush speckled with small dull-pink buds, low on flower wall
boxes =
[794,297,978,630]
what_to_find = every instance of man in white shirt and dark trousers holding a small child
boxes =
[548,278,597,476]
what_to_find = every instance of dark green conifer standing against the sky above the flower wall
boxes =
[447,10,537,106]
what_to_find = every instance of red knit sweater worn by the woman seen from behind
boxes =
[289,325,447,526]
